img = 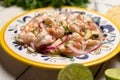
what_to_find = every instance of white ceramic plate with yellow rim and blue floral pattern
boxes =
[0,7,120,69]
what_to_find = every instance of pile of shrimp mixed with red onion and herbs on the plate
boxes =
[16,11,104,56]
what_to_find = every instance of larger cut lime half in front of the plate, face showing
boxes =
[57,63,94,80]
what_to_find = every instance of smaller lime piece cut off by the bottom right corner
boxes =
[105,68,120,80]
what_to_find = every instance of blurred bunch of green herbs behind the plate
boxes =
[4,0,89,9]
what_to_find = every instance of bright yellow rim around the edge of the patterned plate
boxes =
[0,6,120,69]
